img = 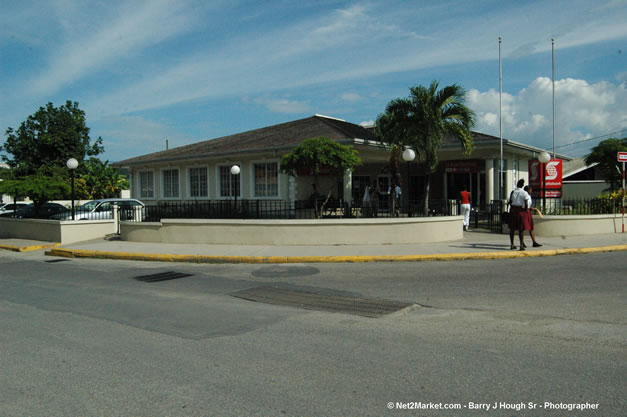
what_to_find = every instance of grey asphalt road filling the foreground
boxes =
[0,252,627,417]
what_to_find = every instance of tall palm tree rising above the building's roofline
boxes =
[377,81,474,216]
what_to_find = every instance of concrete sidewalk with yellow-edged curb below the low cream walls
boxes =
[0,230,627,263]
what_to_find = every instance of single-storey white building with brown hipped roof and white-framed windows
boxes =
[113,115,570,207]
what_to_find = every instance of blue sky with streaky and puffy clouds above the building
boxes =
[0,0,627,162]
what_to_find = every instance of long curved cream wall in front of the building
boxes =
[120,216,463,245]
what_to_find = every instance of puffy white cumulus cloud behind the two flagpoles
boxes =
[466,77,627,154]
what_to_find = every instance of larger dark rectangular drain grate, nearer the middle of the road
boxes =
[231,287,412,317]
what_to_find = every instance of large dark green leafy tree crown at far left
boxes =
[0,101,103,178]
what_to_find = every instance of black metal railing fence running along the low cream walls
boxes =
[2,198,622,221]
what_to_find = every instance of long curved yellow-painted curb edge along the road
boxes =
[45,245,627,264]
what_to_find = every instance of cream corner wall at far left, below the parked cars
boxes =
[0,218,117,244]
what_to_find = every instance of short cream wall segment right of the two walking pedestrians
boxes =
[533,214,622,237]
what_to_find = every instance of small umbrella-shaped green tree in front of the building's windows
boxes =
[281,137,362,216]
